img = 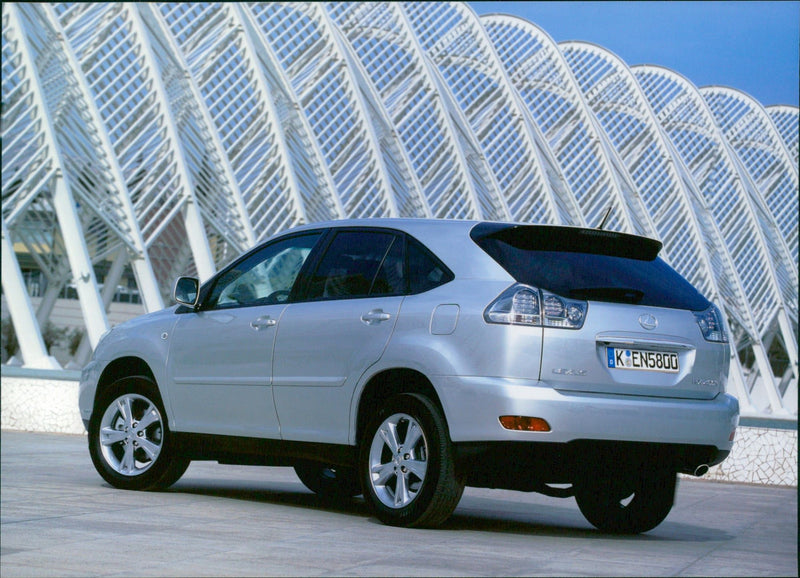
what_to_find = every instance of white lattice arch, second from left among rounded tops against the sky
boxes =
[559,42,774,411]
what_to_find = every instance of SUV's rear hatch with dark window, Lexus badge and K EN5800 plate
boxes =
[472,223,729,399]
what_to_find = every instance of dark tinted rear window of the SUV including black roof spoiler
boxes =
[471,223,709,311]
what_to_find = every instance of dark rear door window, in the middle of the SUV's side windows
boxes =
[308,231,404,299]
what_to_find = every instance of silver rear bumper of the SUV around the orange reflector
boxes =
[435,377,739,452]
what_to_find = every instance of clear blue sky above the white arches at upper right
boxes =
[468,1,800,106]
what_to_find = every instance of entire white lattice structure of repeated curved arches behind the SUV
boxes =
[2,2,798,418]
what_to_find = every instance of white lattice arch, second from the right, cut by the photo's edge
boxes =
[700,86,800,264]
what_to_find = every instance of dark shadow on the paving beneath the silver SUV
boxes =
[167,472,734,542]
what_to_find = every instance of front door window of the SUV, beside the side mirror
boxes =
[206,233,320,309]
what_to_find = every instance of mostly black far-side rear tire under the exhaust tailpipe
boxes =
[575,465,677,534]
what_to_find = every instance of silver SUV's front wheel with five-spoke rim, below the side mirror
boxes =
[89,377,189,490]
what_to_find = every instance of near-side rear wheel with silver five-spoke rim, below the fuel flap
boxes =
[359,394,465,527]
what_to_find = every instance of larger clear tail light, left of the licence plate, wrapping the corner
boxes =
[483,284,589,329]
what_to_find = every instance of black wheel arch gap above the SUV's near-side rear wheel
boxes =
[355,367,449,443]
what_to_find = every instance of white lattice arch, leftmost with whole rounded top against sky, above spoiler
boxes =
[481,15,659,237]
